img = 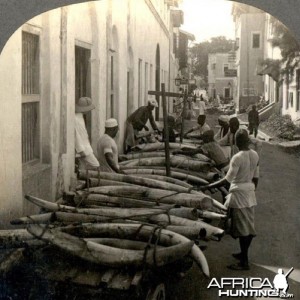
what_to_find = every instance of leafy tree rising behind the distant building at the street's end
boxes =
[190,36,234,82]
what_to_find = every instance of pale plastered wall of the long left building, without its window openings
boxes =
[0,0,178,227]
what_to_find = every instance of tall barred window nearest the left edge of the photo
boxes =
[22,31,40,163]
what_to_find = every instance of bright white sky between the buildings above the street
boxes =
[179,0,234,43]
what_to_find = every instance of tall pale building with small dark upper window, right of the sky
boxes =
[232,3,266,111]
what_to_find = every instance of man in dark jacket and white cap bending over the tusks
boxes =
[124,99,159,152]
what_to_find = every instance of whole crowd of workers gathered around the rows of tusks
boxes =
[75,97,261,270]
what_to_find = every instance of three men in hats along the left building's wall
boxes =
[75,97,160,173]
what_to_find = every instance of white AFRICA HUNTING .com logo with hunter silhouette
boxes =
[207,268,294,299]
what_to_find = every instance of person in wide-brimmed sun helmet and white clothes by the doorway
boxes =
[75,97,99,169]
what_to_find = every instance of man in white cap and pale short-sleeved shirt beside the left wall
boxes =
[97,118,123,173]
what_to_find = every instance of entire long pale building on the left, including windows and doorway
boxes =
[0,0,185,227]
